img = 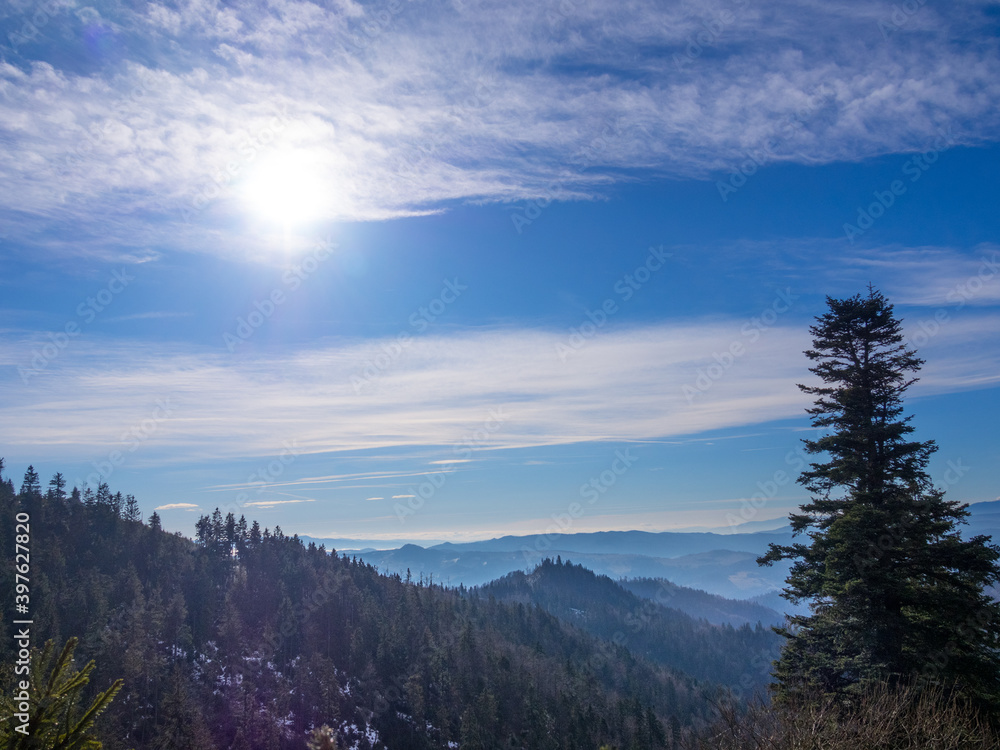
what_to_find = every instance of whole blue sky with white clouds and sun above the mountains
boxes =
[0,0,1000,545]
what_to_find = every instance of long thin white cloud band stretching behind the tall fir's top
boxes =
[0,311,1000,468]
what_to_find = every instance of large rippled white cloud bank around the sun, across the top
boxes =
[0,0,1000,254]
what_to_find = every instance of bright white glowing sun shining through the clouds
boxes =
[243,151,332,229]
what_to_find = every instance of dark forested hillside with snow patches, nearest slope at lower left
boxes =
[0,471,713,750]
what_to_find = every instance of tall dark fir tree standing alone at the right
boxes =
[758,288,1000,711]
